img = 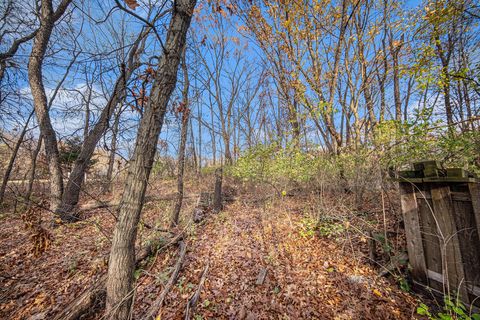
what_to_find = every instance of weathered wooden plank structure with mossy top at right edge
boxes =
[397,161,480,307]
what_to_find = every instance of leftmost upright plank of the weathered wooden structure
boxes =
[400,182,428,284]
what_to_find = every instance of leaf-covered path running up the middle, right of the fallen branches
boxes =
[141,201,415,319]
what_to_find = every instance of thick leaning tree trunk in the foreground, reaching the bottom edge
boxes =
[106,0,196,320]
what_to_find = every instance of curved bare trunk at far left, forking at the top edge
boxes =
[28,0,72,210]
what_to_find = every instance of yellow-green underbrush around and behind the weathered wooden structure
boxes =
[226,128,480,320]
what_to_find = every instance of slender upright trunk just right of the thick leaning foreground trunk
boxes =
[170,48,190,228]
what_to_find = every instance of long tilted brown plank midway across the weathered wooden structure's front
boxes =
[431,183,470,303]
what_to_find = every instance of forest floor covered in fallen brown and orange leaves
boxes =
[0,176,418,320]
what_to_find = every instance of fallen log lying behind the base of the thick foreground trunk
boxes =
[53,232,183,320]
